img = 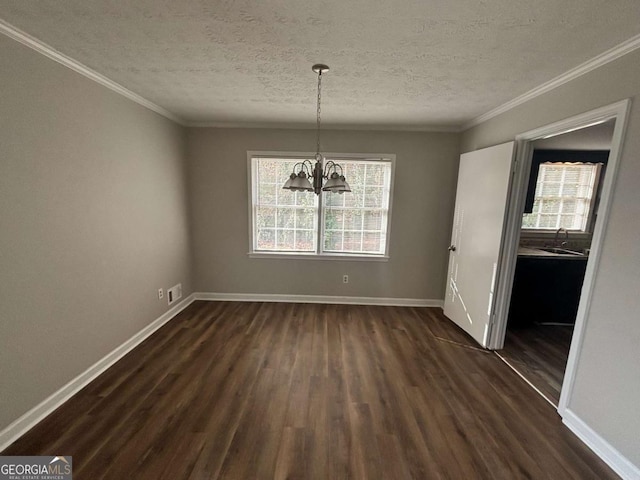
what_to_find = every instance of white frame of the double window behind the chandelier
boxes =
[247,150,396,262]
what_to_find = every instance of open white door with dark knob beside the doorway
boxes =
[444,142,514,347]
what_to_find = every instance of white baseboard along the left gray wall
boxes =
[0,294,195,451]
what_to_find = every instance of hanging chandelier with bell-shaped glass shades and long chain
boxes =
[282,63,351,195]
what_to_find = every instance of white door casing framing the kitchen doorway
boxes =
[488,100,630,416]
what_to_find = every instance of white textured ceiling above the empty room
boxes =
[0,0,640,128]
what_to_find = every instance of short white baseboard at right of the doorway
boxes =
[562,408,640,480]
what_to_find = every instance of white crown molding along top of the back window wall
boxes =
[185,122,462,133]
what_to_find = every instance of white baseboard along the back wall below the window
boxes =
[194,292,444,308]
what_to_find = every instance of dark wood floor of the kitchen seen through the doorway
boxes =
[498,324,573,406]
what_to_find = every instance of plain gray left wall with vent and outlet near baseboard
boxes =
[0,35,191,430]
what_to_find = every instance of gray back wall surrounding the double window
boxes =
[188,128,460,299]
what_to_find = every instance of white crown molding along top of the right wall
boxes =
[460,35,640,131]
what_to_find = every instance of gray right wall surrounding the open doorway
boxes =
[462,50,640,465]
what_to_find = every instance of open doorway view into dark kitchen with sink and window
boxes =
[498,119,615,408]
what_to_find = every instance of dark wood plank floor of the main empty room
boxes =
[3,302,617,480]
